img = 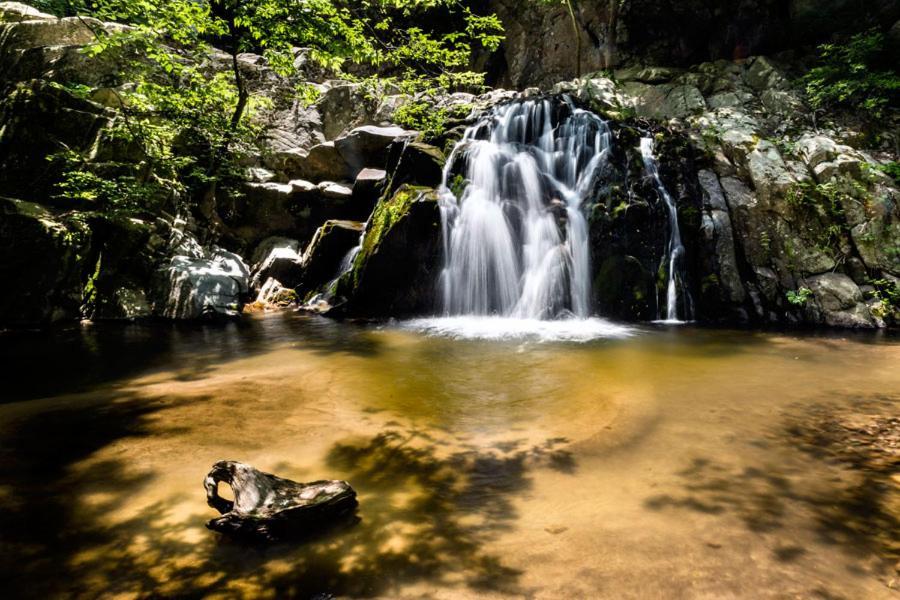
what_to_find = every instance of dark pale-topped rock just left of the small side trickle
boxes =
[302,220,365,292]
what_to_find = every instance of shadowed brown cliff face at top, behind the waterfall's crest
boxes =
[486,0,900,89]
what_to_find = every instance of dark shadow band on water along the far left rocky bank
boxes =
[0,312,380,402]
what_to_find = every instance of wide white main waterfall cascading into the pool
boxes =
[440,99,612,320]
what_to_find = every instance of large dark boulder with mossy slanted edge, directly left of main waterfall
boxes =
[336,186,441,317]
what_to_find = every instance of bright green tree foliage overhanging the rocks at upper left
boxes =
[47,0,502,216]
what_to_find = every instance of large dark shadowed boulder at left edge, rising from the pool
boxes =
[0,198,90,327]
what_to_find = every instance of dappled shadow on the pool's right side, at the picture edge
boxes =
[644,395,900,570]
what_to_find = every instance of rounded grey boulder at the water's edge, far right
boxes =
[803,273,875,329]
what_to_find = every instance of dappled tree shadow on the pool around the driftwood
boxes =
[0,398,577,598]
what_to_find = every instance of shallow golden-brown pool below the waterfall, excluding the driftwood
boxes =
[0,314,900,599]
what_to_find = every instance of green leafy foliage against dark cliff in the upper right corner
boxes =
[803,29,900,118]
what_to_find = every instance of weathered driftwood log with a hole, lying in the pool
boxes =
[203,460,358,540]
